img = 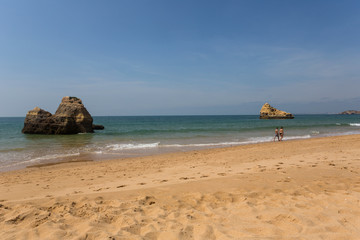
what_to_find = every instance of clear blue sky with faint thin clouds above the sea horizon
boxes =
[0,0,360,116]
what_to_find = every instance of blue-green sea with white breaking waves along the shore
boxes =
[0,115,360,172]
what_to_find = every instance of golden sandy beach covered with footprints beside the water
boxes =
[0,135,360,240]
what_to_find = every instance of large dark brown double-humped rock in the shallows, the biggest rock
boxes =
[22,97,104,134]
